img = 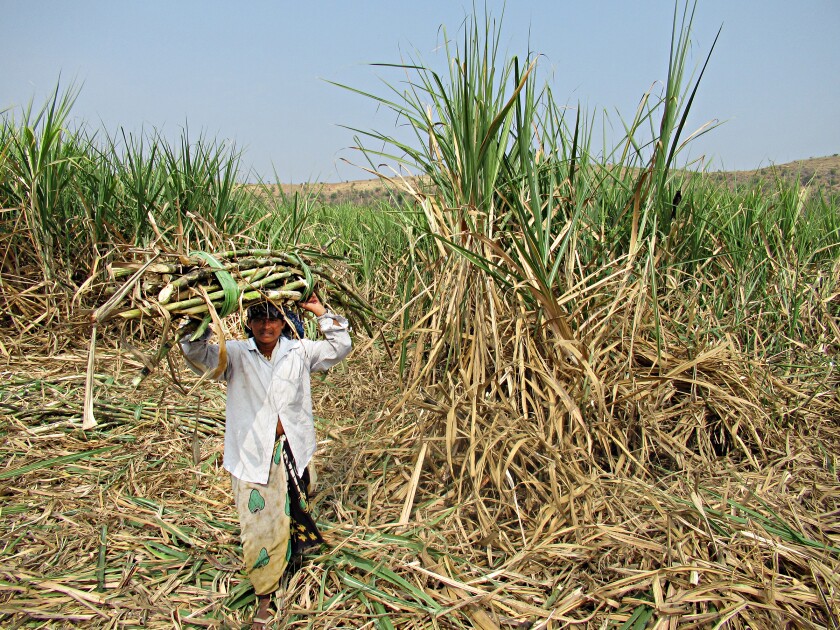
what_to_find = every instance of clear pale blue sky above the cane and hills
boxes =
[0,0,840,182]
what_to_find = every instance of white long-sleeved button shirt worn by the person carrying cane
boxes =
[181,313,352,483]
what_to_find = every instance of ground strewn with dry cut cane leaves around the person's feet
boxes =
[0,304,840,628]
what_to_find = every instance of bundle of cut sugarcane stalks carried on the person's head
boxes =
[82,249,373,428]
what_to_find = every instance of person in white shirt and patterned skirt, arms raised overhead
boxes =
[181,294,352,628]
